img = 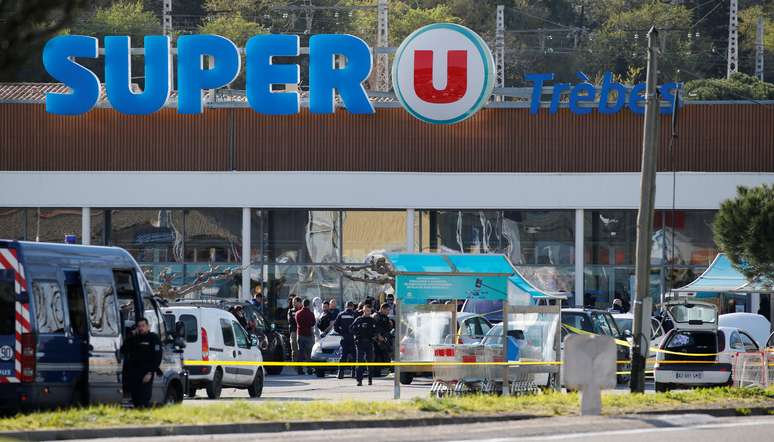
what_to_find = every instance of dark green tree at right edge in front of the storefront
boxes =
[713,184,774,285]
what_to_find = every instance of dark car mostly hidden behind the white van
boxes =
[174,299,290,375]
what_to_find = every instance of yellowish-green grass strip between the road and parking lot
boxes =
[0,388,774,431]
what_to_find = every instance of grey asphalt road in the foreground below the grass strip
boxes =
[65,414,774,442]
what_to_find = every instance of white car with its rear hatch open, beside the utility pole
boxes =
[654,299,759,392]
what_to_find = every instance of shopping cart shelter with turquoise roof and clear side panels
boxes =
[387,254,565,397]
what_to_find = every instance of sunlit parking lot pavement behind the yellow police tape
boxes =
[183,370,653,405]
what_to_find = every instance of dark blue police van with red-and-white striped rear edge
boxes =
[0,240,187,410]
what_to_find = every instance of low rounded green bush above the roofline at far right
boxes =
[685,72,774,100]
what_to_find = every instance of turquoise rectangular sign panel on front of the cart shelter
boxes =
[395,275,508,304]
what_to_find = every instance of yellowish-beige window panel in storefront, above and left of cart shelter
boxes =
[342,210,406,263]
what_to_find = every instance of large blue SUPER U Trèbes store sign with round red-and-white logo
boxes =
[42,23,679,124]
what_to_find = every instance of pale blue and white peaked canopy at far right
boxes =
[672,253,774,293]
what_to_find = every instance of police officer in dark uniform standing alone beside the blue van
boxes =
[121,318,162,408]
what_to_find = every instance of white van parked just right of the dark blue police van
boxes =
[163,305,264,399]
